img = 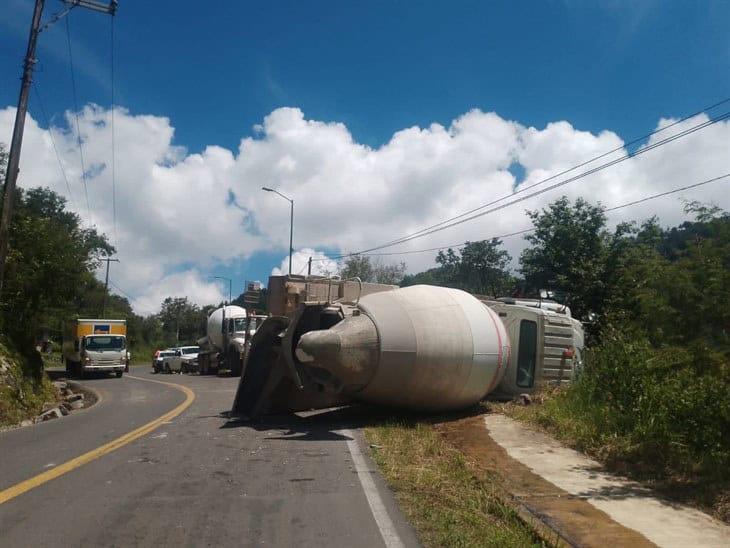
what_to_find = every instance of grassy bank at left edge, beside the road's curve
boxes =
[0,340,58,426]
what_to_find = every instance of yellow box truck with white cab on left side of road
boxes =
[62,319,129,377]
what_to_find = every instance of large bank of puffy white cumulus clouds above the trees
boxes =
[0,105,730,312]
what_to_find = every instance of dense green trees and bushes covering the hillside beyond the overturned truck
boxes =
[506,200,730,520]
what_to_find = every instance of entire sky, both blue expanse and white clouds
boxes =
[0,0,730,313]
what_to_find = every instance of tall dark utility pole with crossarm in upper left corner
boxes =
[0,0,117,296]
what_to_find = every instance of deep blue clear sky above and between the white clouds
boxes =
[0,0,730,308]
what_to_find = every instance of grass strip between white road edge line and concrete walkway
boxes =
[365,423,540,547]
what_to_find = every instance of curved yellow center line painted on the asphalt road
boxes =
[0,375,195,504]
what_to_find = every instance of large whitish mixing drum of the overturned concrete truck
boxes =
[296,285,510,410]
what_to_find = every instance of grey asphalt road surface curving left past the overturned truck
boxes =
[0,368,417,547]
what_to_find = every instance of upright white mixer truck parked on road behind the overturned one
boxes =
[198,305,265,376]
